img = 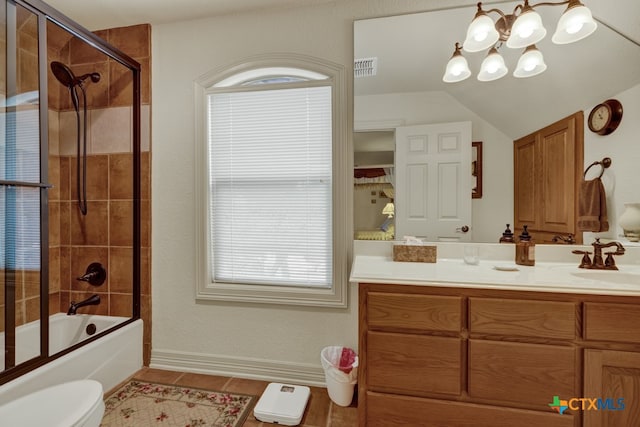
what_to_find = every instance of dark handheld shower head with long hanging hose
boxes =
[51,61,100,215]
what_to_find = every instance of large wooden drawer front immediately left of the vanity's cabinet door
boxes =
[469,340,579,410]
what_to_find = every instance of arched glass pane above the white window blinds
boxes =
[213,67,329,88]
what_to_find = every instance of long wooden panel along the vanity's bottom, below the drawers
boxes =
[360,393,574,427]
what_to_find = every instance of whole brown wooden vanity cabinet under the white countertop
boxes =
[358,283,640,427]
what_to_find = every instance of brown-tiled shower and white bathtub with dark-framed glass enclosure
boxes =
[0,0,142,396]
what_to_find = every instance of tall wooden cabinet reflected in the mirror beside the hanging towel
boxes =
[513,111,584,243]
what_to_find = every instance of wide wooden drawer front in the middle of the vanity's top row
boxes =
[469,298,576,340]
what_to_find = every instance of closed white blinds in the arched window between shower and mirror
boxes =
[208,85,332,287]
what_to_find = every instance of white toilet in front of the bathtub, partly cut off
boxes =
[0,380,104,427]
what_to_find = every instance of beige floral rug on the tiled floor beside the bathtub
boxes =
[100,380,256,427]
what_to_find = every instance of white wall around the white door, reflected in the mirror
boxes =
[354,92,513,243]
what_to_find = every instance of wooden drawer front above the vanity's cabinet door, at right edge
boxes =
[584,302,640,343]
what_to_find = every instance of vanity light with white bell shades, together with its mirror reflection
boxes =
[442,0,598,83]
